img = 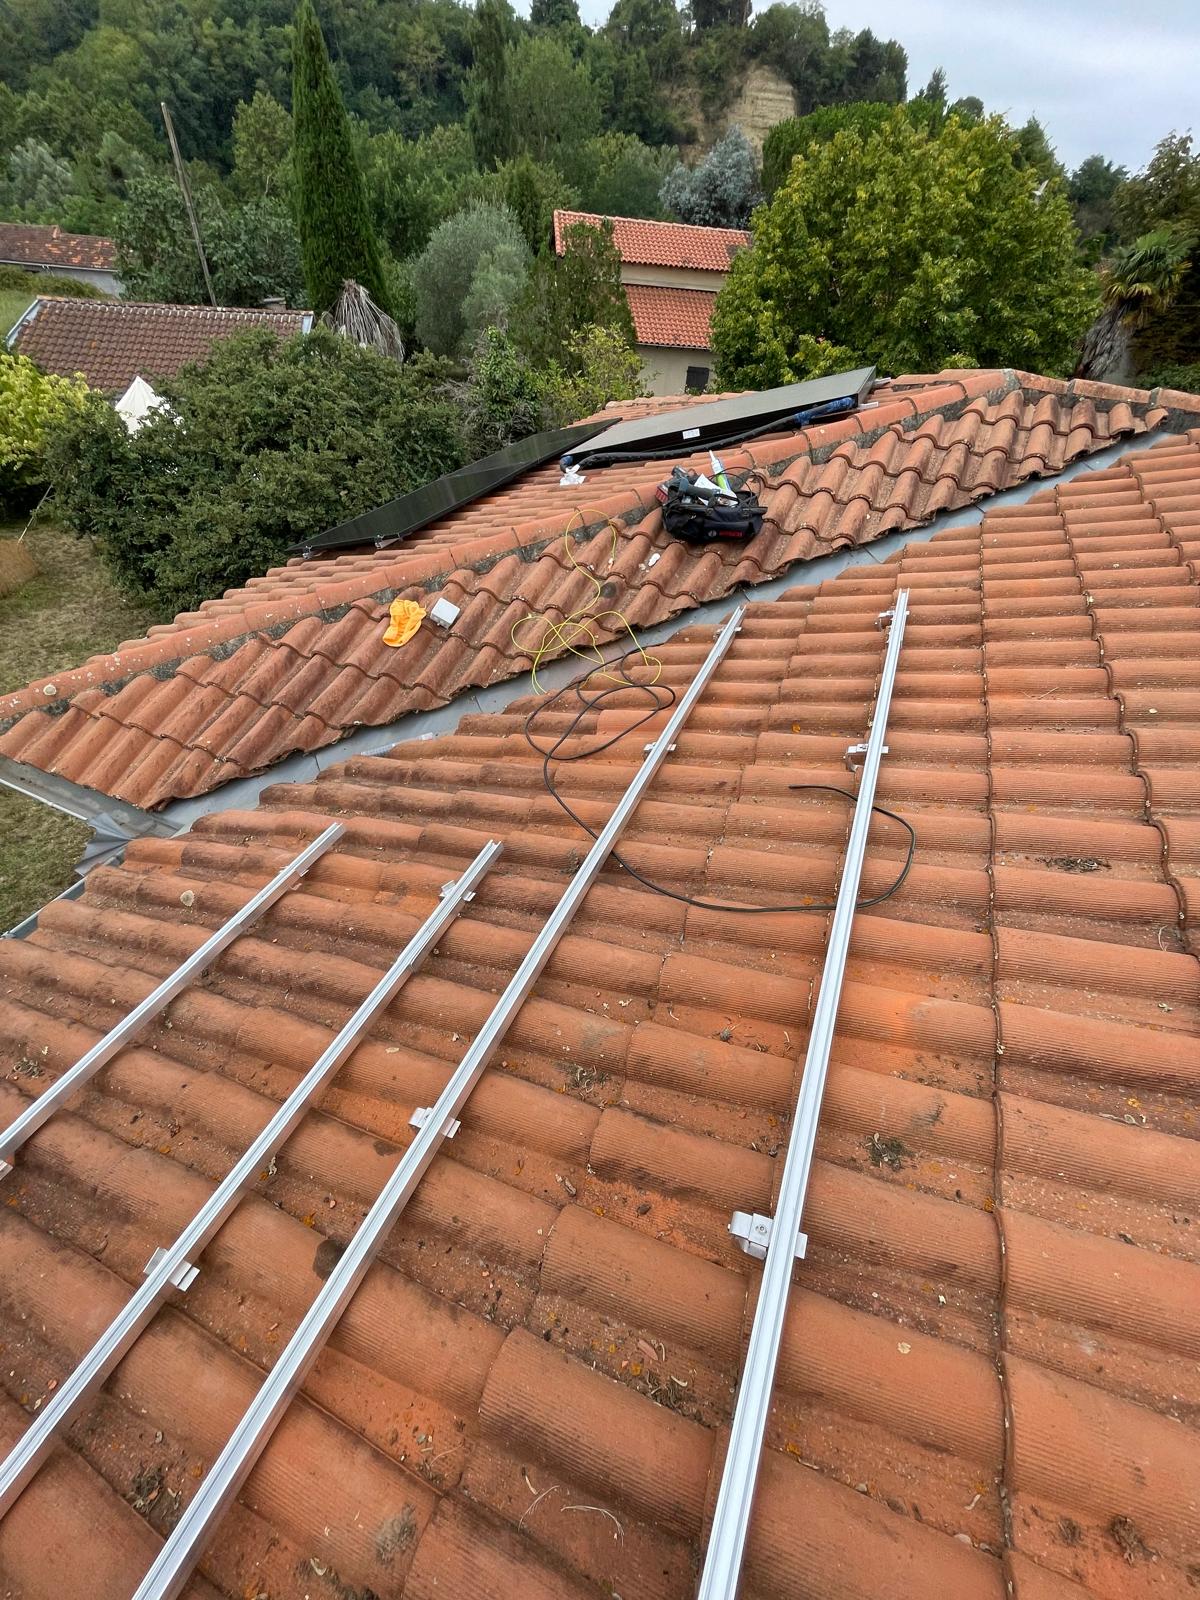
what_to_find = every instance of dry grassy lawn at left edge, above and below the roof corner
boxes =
[0,518,157,933]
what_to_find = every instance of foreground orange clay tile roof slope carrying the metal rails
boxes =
[0,444,1200,1600]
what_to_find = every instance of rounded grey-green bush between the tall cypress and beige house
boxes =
[413,205,530,355]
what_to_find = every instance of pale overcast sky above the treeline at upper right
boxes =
[569,0,1200,171]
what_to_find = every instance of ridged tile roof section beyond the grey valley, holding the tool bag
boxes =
[0,371,1200,808]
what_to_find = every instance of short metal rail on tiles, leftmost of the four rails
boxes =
[0,822,346,1178]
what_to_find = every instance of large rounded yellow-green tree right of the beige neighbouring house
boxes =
[712,110,1096,387]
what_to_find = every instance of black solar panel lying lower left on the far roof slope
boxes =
[290,422,610,555]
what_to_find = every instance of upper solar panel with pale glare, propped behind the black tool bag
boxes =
[563,366,875,467]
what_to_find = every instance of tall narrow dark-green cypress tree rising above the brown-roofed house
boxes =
[291,0,390,312]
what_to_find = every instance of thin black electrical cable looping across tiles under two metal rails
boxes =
[522,646,917,917]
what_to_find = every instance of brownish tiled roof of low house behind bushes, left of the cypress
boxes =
[10,294,312,394]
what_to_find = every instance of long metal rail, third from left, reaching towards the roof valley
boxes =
[134,606,746,1600]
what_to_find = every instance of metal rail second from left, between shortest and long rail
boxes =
[0,835,504,1517]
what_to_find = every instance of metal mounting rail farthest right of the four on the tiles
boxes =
[699,589,909,1600]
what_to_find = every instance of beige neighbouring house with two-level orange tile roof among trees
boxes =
[554,211,750,395]
